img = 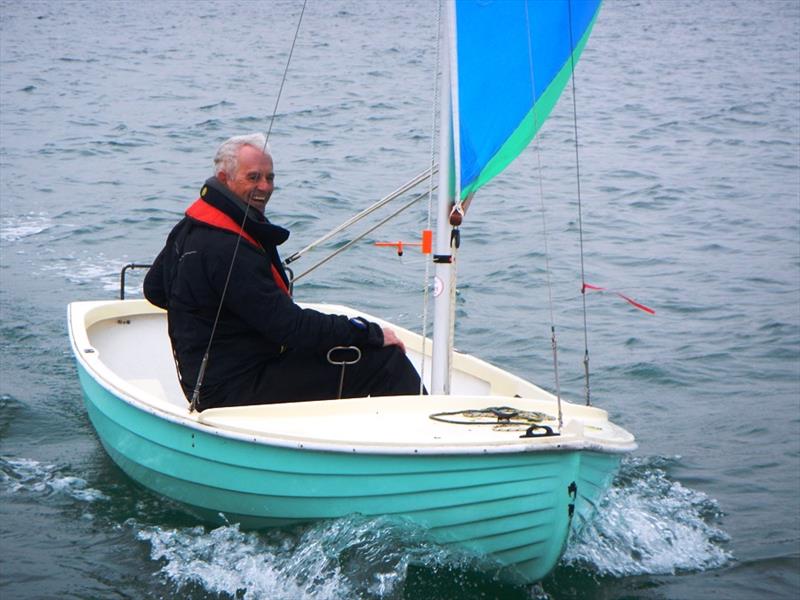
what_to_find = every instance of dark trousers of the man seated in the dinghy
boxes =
[212,346,420,408]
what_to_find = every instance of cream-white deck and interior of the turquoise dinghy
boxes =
[70,300,635,454]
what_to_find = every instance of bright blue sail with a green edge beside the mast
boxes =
[451,0,600,199]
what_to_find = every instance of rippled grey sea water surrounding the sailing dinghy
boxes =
[0,0,800,600]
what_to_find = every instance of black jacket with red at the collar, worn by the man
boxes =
[144,178,383,409]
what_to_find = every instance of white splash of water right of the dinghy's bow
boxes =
[563,458,732,577]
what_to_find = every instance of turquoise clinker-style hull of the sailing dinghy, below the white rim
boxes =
[78,361,621,582]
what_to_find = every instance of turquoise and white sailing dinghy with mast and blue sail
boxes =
[68,0,636,582]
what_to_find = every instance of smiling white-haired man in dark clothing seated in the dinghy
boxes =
[144,134,420,410]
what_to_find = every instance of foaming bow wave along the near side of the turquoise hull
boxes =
[131,516,478,600]
